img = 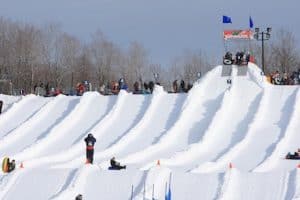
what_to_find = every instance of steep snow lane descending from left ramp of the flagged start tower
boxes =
[124,66,228,166]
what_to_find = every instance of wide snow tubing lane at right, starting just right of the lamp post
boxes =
[193,77,296,172]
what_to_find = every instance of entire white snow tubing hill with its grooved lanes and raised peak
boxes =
[0,63,300,200]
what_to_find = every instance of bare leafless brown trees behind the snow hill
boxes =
[0,17,300,93]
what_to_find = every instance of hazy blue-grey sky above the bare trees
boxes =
[0,0,300,64]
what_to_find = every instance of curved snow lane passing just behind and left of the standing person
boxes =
[14,92,113,160]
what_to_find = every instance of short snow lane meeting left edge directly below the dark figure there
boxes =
[0,95,51,138]
